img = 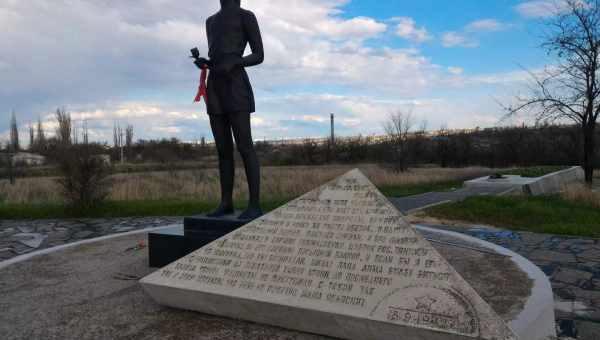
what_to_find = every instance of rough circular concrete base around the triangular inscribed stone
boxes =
[0,228,552,340]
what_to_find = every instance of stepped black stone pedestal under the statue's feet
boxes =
[148,213,252,268]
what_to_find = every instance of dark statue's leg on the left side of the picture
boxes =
[208,115,235,217]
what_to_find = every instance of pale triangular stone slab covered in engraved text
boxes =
[141,170,517,340]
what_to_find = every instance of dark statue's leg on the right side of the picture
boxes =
[229,112,263,219]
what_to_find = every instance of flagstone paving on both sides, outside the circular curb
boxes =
[0,217,600,340]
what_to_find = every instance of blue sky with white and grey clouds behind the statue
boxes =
[0,0,564,141]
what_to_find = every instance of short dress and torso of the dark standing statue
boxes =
[206,7,263,115]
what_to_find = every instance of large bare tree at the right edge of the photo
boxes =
[508,0,600,184]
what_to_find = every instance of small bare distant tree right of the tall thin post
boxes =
[383,110,413,172]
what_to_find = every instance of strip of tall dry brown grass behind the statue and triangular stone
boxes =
[0,165,492,204]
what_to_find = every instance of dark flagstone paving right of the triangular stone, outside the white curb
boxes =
[427,225,600,340]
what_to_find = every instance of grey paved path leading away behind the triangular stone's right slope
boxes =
[390,187,509,214]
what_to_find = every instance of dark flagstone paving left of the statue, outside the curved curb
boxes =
[0,217,182,261]
